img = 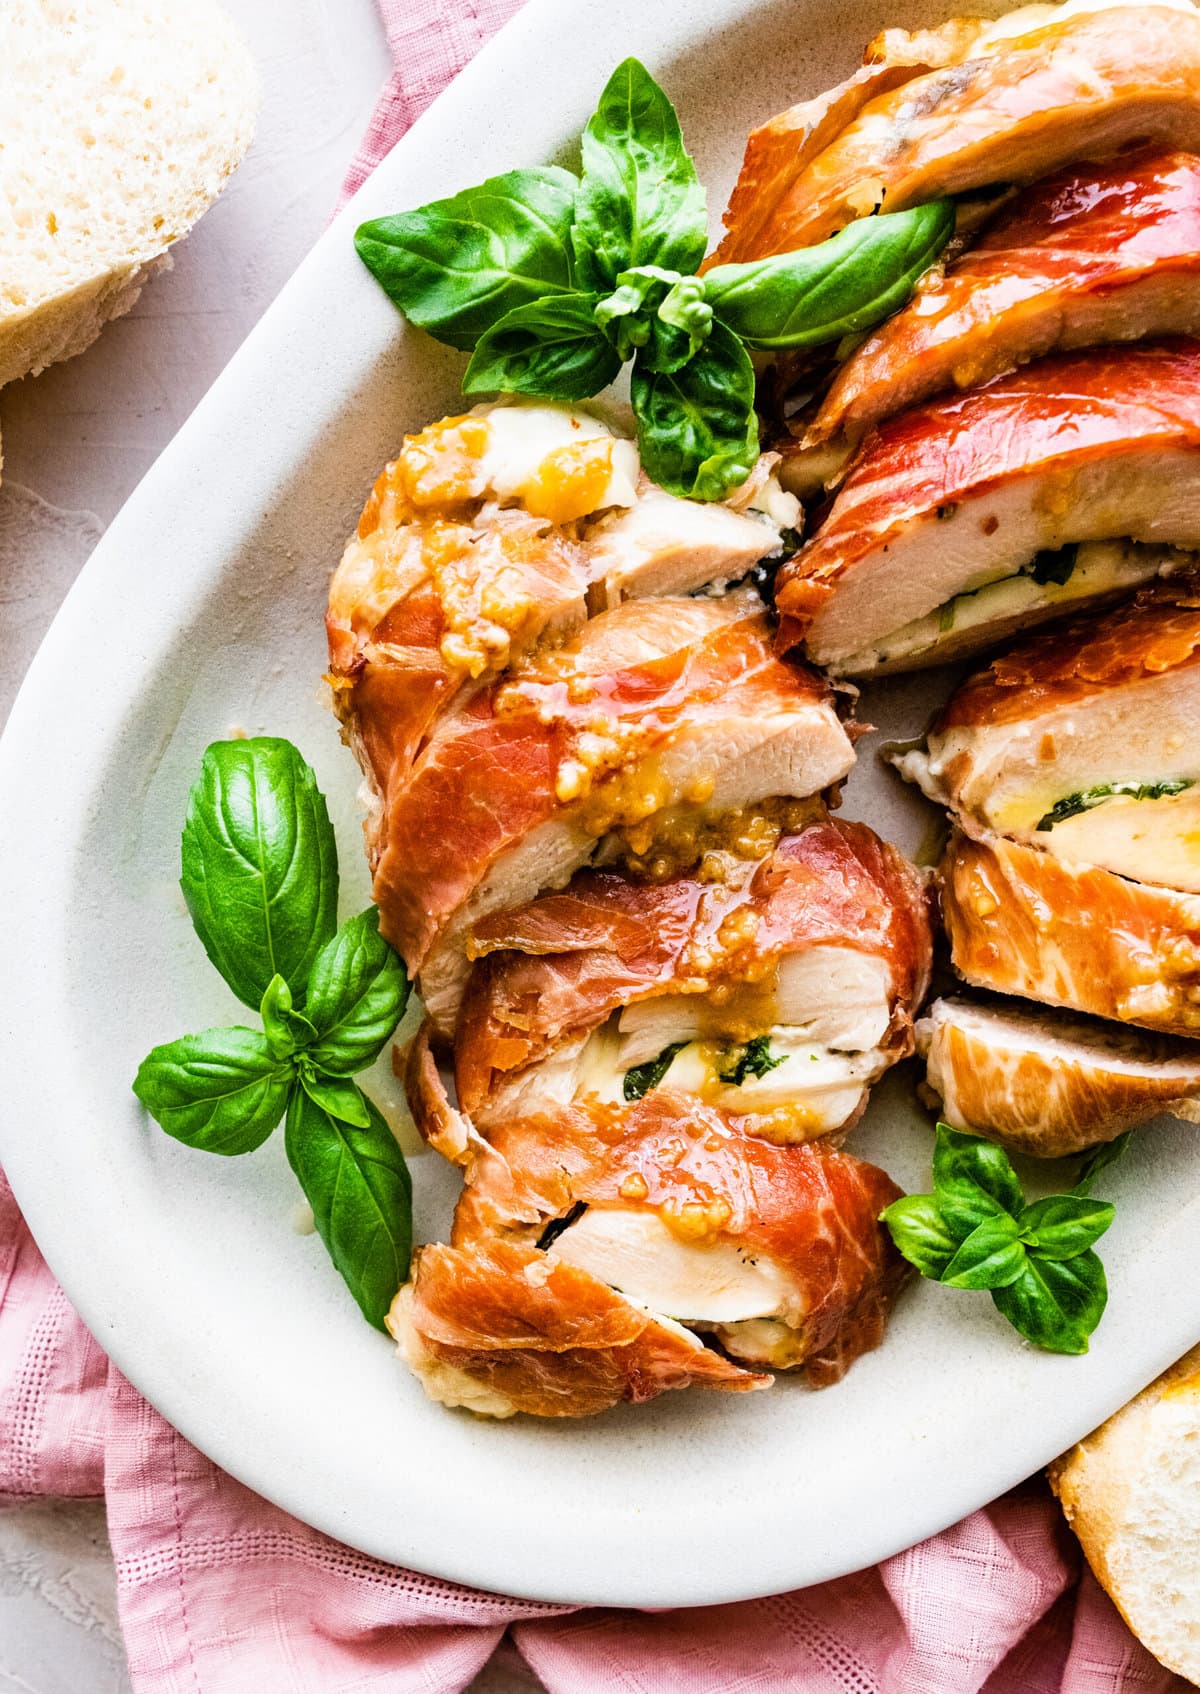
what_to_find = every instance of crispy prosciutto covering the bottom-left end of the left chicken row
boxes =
[388,1240,771,1418]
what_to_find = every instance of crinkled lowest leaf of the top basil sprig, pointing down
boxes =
[629,324,758,500]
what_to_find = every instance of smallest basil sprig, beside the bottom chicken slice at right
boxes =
[880,1123,1129,1354]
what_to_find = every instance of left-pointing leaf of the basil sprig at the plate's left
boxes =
[134,1028,292,1155]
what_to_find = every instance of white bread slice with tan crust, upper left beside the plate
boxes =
[0,0,258,386]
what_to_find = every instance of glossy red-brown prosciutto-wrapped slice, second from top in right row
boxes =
[807,152,1200,444]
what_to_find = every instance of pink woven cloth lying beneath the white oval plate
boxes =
[0,0,1186,1694]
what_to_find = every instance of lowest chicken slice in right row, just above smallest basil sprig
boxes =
[917,999,1200,1159]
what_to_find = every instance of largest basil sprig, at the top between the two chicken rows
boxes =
[354,59,954,500]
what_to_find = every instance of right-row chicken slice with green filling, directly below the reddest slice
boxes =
[893,578,1200,894]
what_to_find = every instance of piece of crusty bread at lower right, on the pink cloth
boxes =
[1049,1347,1200,1684]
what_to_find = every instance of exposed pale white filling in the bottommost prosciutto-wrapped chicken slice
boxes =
[547,1206,786,1323]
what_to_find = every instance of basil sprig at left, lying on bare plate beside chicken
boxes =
[134,737,412,1328]
